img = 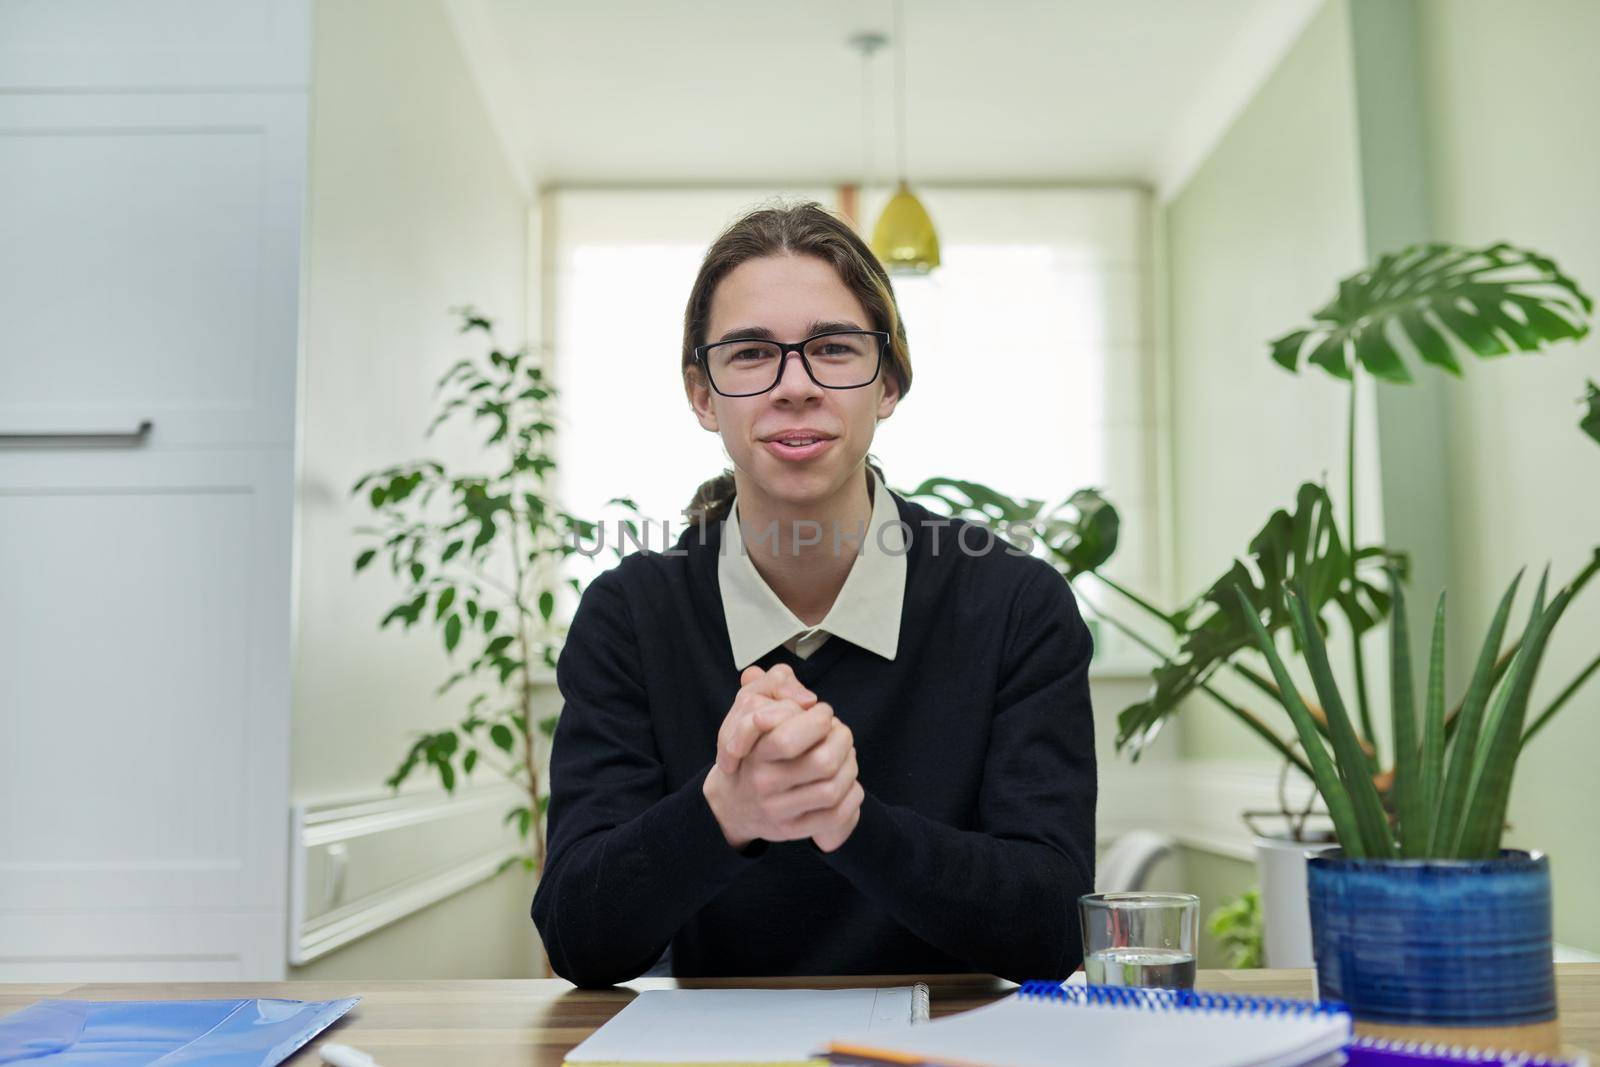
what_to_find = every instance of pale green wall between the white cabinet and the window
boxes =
[293,0,538,977]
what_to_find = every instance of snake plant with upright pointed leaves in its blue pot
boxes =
[1238,574,1573,1053]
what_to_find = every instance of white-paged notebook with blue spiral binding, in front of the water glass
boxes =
[829,982,1350,1067]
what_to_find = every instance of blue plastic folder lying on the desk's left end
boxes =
[0,997,360,1067]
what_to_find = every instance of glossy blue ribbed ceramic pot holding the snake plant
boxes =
[1306,849,1555,1027]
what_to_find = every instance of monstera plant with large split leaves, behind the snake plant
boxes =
[915,243,1600,800]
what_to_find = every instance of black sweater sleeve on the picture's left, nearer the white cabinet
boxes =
[531,568,766,989]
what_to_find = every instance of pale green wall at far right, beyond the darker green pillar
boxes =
[1421,0,1600,952]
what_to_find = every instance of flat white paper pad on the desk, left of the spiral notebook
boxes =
[566,982,928,1067]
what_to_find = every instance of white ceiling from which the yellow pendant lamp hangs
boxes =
[451,0,1317,187]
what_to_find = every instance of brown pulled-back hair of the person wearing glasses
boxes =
[683,200,910,525]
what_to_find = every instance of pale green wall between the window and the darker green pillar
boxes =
[1163,0,1387,760]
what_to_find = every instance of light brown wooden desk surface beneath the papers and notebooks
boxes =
[0,963,1600,1067]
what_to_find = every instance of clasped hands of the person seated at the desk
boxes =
[702,664,866,853]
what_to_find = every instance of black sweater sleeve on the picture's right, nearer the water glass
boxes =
[813,569,1098,982]
